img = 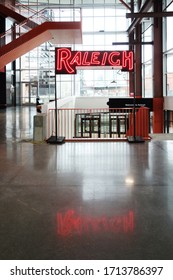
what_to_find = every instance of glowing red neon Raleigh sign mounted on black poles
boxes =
[55,48,133,74]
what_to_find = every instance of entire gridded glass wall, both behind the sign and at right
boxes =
[6,0,173,105]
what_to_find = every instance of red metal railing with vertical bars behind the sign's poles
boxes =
[47,108,149,140]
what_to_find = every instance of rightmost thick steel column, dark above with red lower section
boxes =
[153,1,164,133]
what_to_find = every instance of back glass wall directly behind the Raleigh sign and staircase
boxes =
[11,0,129,104]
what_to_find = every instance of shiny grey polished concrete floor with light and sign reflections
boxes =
[0,107,173,260]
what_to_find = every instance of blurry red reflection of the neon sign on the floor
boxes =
[57,209,134,236]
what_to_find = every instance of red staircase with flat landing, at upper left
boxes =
[0,4,82,69]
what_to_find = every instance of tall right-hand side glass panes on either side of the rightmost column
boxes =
[142,0,173,97]
